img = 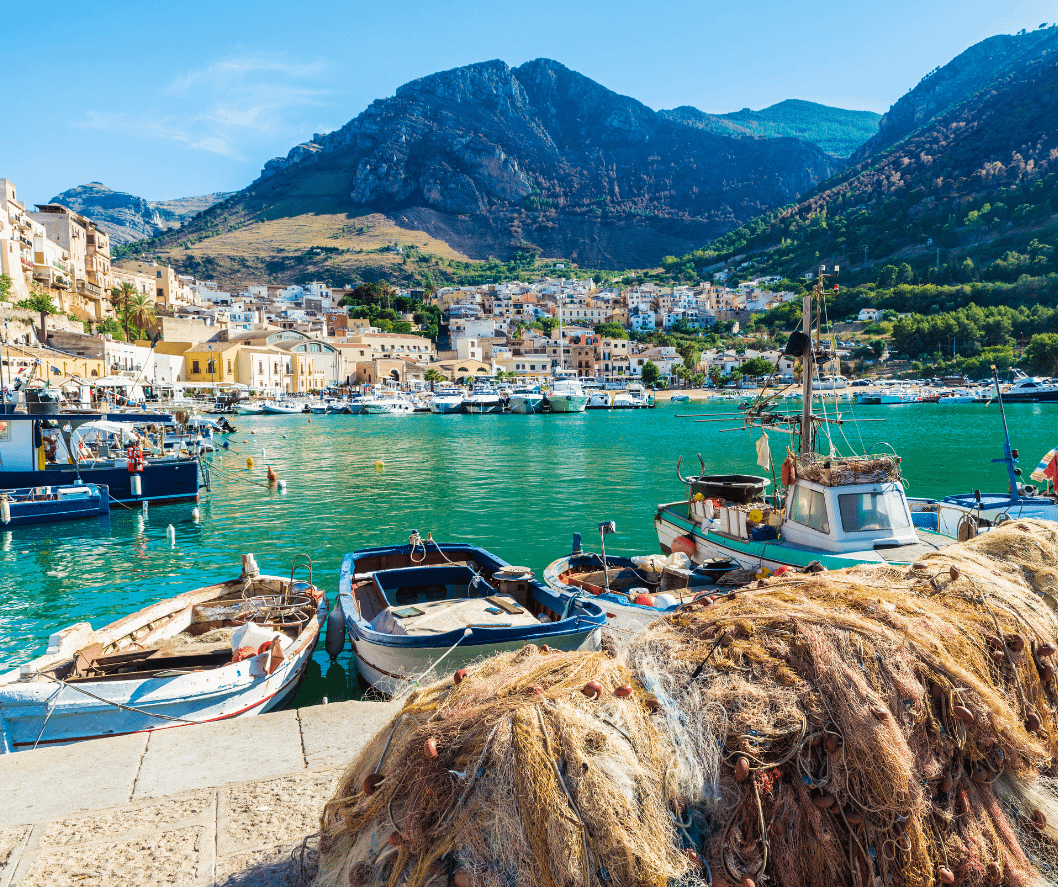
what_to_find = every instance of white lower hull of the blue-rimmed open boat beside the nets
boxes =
[350,629,602,695]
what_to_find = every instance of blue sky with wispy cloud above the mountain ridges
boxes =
[6,0,1055,202]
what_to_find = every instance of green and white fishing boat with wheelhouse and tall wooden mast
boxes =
[654,266,953,572]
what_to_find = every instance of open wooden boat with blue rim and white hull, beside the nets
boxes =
[339,535,606,695]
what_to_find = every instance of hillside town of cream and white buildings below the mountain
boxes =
[0,179,808,394]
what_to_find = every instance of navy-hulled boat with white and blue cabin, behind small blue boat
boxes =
[0,412,204,503]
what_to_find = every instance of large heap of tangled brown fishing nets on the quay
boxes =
[316,521,1058,887]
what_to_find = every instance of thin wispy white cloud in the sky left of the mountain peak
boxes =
[80,55,329,160]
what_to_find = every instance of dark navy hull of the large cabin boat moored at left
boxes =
[0,459,199,503]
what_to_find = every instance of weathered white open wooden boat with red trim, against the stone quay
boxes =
[0,555,327,753]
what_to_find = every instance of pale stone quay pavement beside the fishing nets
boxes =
[0,702,398,887]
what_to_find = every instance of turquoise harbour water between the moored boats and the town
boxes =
[0,397,1058,705]
